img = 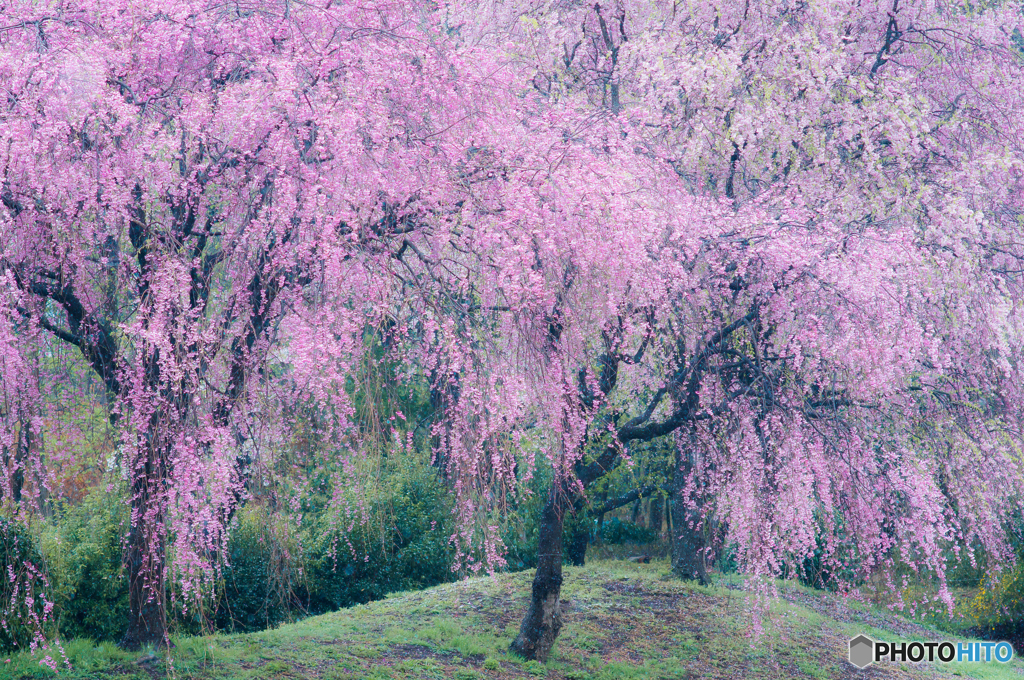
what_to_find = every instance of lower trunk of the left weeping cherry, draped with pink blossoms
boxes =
[121,445,168,649]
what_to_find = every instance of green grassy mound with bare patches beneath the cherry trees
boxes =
[0,561,1024,680]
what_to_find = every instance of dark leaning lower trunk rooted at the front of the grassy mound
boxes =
[510,485,568,663]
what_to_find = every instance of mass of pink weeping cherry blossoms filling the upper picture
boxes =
[0,0,1024,655]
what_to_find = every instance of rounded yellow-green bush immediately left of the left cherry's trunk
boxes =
[42,486,128,641]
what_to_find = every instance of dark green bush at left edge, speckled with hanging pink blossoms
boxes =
[0,516,49,652]
